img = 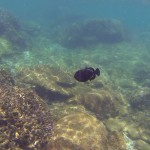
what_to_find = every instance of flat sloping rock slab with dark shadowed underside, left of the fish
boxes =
[17,66,75,102]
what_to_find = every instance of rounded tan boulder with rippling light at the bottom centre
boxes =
[47,112,126,150]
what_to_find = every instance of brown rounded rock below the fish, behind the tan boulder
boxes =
[82,90,119,119]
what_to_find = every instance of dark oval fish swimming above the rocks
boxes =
[74,67,100,82]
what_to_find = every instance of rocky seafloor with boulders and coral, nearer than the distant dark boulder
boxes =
[0,9,150,150]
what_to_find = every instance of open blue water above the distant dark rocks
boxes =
[1,0,150,28]
